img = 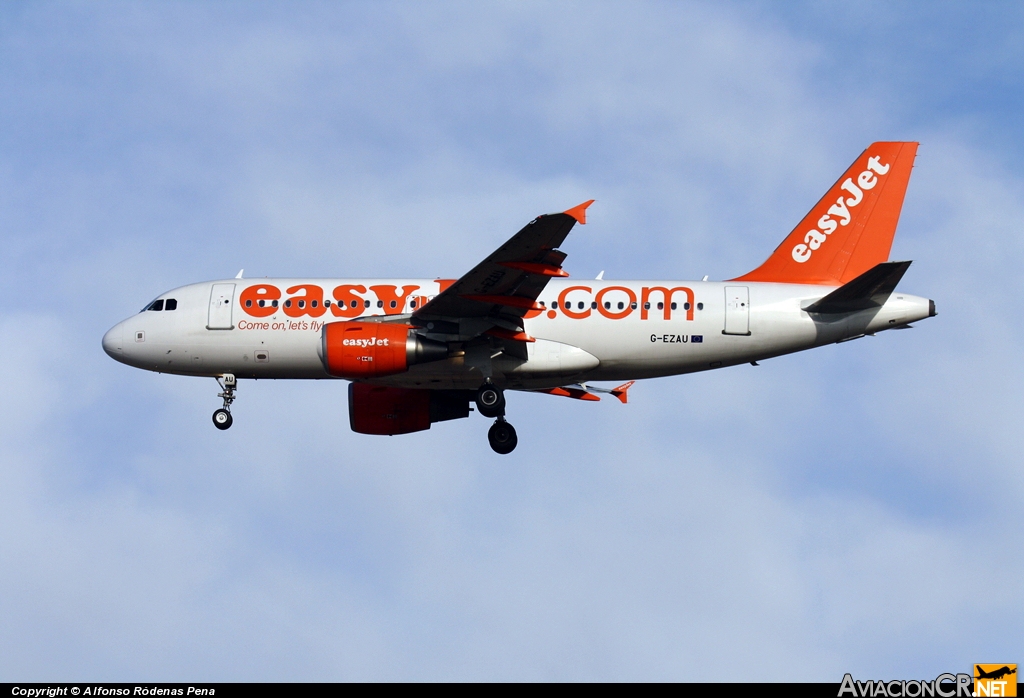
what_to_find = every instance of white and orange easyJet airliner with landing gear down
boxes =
[102,142,936,454]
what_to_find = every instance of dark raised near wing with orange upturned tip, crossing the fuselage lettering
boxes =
[413,200,594,331]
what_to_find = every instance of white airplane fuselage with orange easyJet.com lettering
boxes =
[103,278,934,389]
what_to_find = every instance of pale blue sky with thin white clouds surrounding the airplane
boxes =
[0,2,1024,681]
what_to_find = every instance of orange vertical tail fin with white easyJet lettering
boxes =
[732,142,918,286]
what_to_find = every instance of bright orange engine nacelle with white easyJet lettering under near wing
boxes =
[321,322,447,379]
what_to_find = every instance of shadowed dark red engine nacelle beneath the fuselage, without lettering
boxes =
[348,383,473,436]
